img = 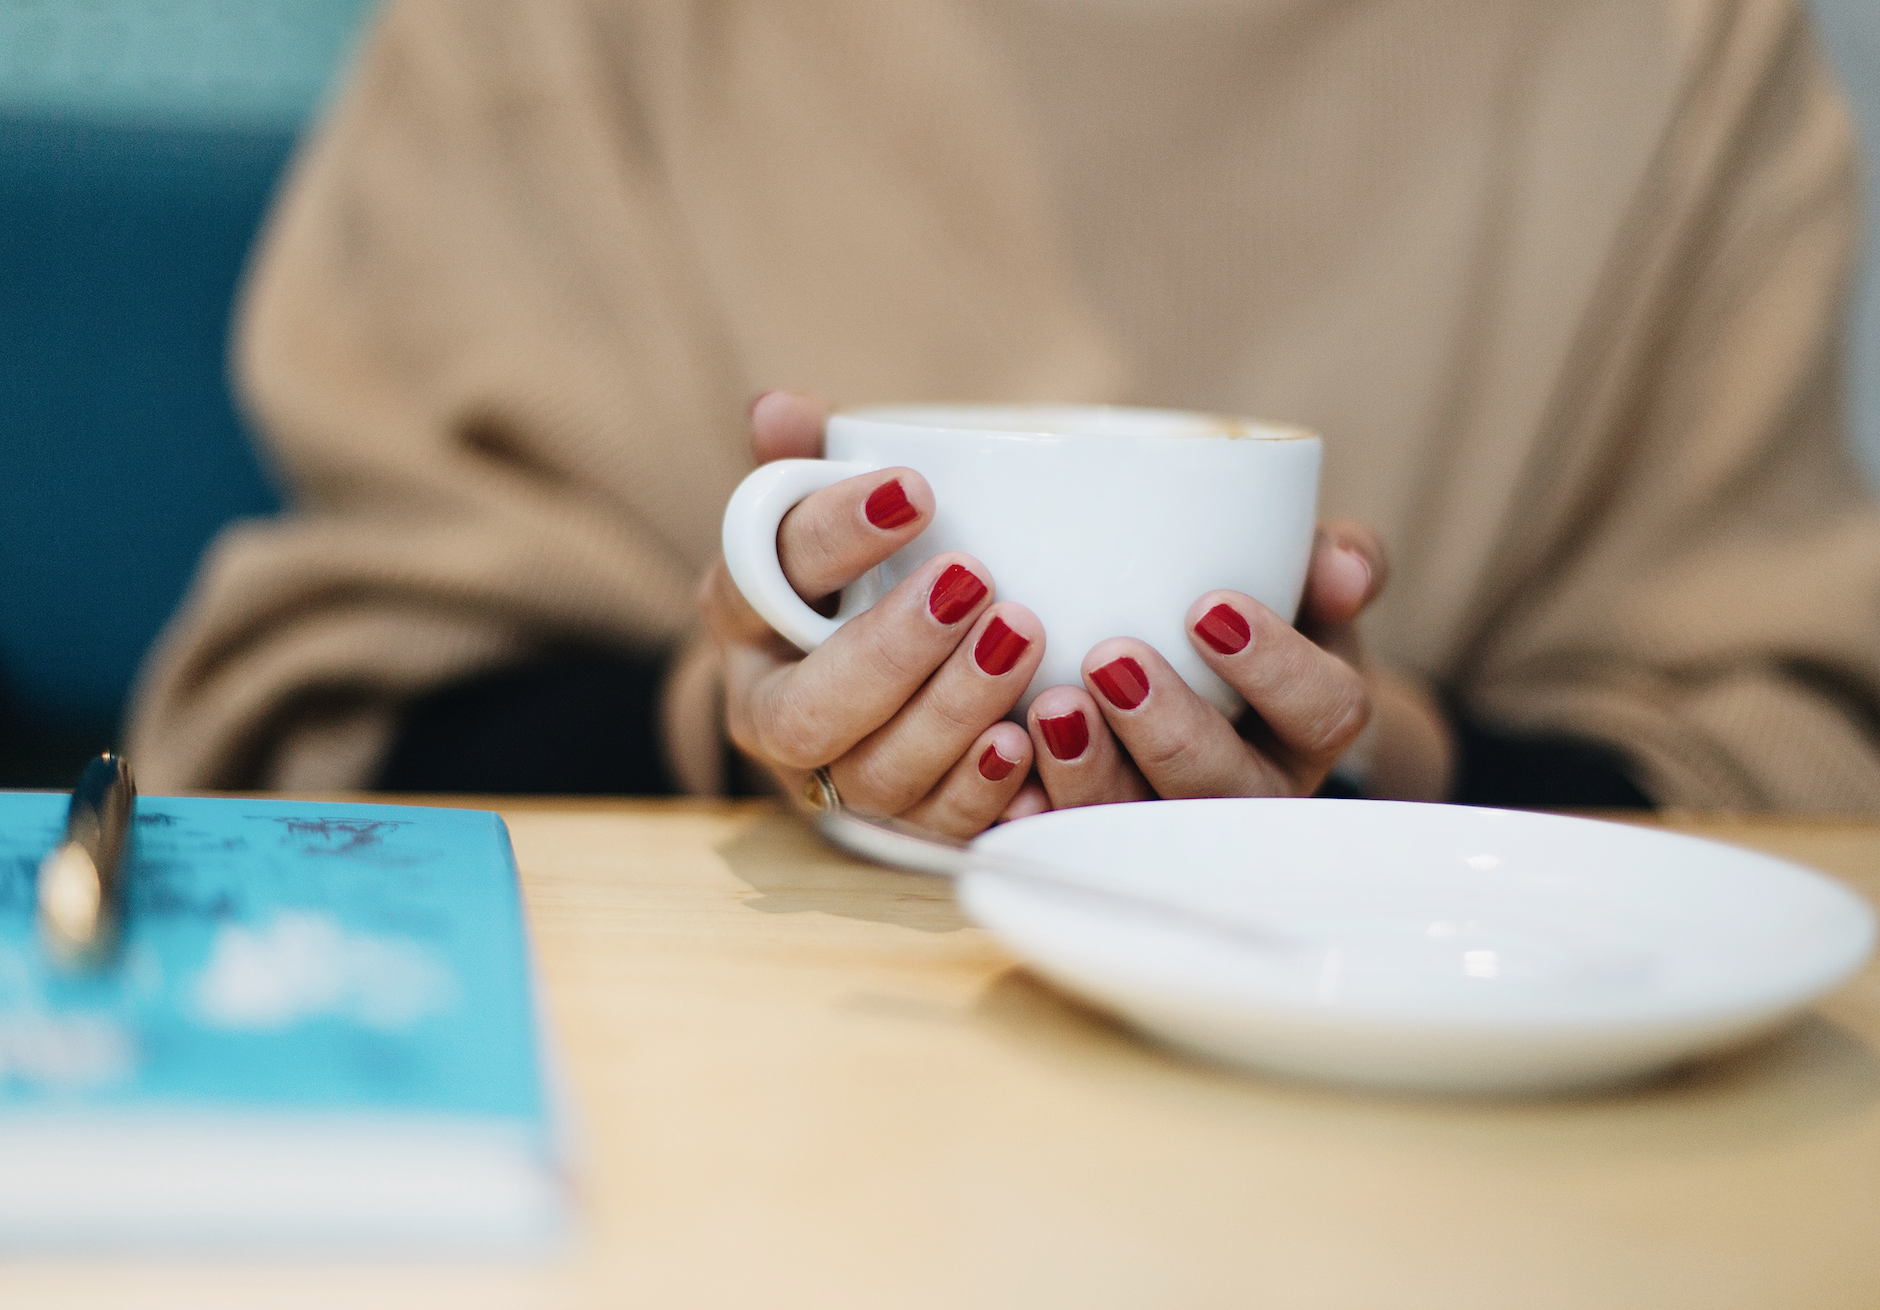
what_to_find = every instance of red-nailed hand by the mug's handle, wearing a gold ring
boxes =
[699,391,1045,836]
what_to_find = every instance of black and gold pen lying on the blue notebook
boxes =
[38,752,137,968]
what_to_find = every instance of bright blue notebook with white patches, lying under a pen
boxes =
[0,793,568,1250]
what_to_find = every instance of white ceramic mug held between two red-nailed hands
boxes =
[724,406,1320,718]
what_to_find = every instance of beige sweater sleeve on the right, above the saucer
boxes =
[1461,6,1880,812]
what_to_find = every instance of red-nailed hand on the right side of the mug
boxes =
[1013,522,1453,814]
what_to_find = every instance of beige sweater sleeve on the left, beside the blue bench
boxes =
[119,0,748,788]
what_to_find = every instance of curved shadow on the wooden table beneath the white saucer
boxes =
[974,968,1880,1154]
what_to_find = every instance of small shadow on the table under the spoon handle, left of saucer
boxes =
[716,814,968,932]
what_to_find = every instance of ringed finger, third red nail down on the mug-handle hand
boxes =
[829,601,1045,808]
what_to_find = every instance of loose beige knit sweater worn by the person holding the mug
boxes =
[130,0,1880,810]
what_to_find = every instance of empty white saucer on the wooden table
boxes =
[961,801,1874,1092]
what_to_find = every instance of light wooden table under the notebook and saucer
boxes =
[11,803,1880,1310]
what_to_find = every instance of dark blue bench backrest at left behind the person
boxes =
[0,117,293,782]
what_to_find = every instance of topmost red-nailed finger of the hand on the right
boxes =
[1186,592,1371,767]
